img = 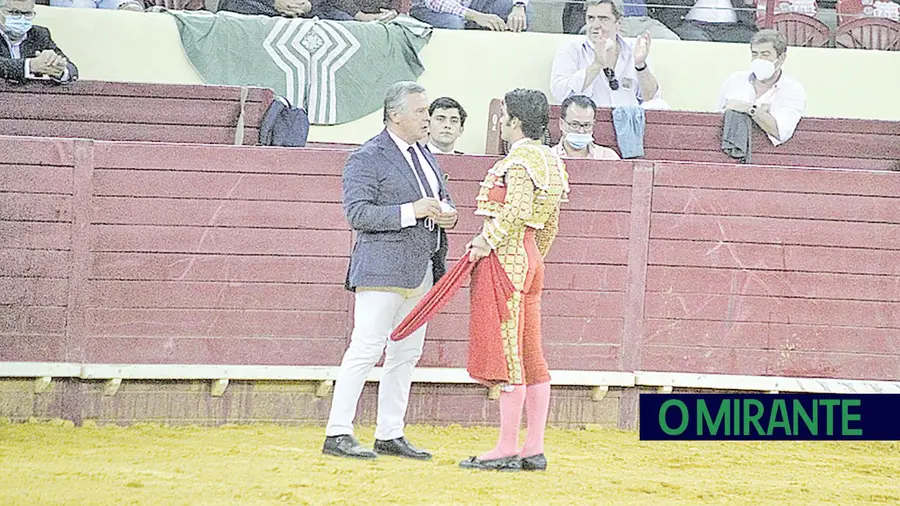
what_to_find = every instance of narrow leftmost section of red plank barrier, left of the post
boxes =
[0,139,77,361]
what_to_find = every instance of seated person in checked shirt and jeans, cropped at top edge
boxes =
[409,0,531,32]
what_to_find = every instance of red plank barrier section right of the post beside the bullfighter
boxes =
[642,163,900,379]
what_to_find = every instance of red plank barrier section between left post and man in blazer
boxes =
[86,142,351,365]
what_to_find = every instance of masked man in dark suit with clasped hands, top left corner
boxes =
[0,0,78,83]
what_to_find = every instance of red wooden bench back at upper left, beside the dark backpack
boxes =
[0,81,274,145]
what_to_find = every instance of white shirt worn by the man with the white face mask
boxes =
[719,70,806,146]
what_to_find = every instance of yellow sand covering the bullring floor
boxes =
[0,422,900,505]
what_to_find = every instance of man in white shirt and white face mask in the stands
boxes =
[719,30,806,146]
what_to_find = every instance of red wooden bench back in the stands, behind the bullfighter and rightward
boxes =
[485,100,900,170]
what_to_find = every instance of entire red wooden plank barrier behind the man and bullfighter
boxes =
[0,137,900,380]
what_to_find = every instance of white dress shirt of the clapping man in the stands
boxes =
[550,37,661,107]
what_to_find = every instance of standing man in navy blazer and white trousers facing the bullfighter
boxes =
[322,82,458,460]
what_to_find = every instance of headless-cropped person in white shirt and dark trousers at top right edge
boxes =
[655,0,756,43]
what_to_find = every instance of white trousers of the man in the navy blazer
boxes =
[325,262,434,440]
